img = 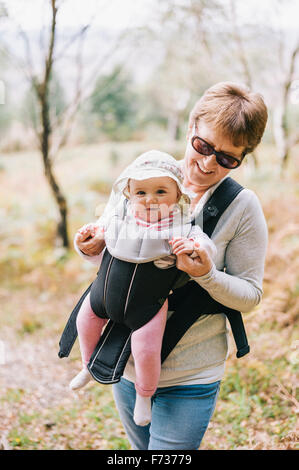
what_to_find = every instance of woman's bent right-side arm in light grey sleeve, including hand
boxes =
[178,193,268,312]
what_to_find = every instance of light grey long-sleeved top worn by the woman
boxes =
[75,174,268,387]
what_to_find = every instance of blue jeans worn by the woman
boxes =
[113,378,220,450]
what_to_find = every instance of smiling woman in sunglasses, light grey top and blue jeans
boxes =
[76,82,267,450]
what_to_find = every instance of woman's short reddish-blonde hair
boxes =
[189,82,268,153]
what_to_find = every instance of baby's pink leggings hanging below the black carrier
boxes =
[77,294,168,397]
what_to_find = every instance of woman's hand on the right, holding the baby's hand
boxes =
[176,242,213,277]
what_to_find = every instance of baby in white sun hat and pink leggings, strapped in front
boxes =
[70,150,216,426]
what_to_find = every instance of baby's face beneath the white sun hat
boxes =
[129,176,180,222]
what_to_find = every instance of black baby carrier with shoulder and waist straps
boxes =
[58,178,249,384]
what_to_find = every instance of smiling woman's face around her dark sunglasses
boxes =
[184,122,244,190]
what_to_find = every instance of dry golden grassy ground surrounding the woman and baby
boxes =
[0,142,299,450]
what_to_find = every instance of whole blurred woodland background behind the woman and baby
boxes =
[0,0,299,450]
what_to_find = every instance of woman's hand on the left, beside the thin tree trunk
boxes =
[75,224,105,256]
